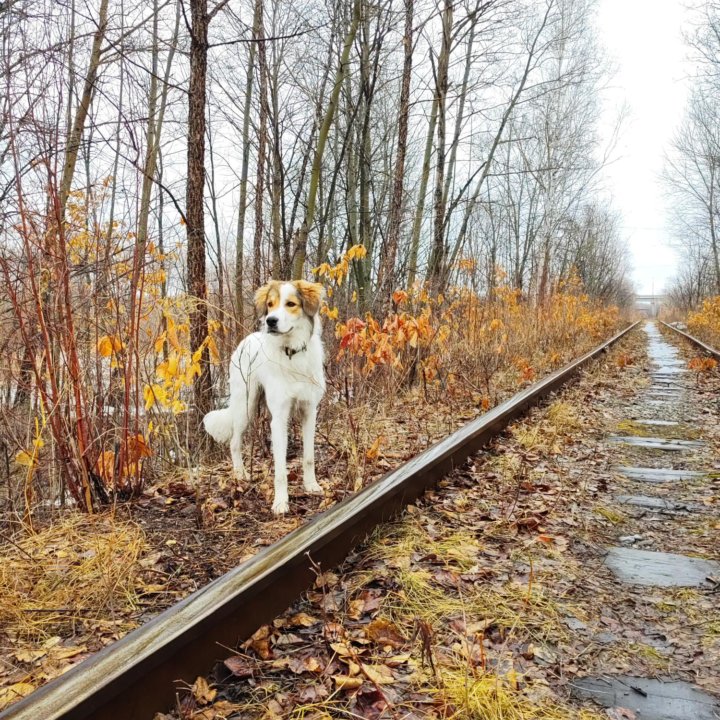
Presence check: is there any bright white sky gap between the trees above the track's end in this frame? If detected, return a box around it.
[598,0,690,293]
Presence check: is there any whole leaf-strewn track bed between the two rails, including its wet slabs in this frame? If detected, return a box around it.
[162,325,720,720]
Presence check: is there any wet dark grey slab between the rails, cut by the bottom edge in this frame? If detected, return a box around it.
[571,676,720,720]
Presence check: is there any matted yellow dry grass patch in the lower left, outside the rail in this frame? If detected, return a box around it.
[0,513,147,640]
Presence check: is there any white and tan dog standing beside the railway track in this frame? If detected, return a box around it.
[203,280,325,514]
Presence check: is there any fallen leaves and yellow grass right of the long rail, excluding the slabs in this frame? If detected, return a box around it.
[158,336,720,720]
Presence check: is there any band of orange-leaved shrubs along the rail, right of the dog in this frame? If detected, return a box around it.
[324,262,619,402]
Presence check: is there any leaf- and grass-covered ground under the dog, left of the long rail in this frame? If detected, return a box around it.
[0,334,620,713]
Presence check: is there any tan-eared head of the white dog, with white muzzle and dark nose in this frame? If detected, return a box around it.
[255,280,325,336]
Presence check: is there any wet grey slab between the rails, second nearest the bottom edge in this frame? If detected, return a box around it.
[605,547,720,587]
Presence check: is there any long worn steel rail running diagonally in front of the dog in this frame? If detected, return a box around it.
[0,323,637,720]
